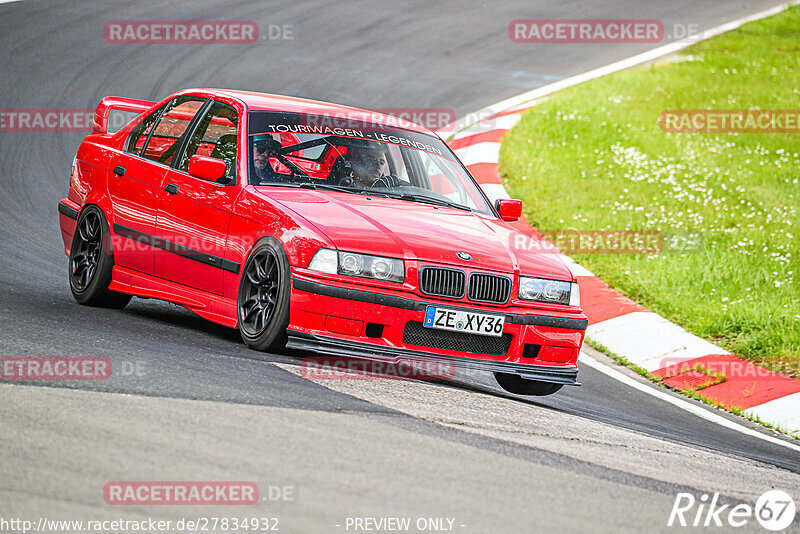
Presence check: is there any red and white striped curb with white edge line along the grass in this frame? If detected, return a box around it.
[439,4,800,437]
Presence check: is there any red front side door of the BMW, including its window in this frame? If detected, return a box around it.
[154,101,240,295]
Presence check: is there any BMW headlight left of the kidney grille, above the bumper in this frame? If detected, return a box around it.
[308,248,405,283]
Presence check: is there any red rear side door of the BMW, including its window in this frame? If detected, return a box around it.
[108,96,207,275]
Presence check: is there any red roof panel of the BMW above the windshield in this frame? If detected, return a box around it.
[186,89,433,134]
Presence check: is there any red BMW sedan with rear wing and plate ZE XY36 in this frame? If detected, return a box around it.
[58,89,587,395]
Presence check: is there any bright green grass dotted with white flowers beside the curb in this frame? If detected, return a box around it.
[500,7,800,377]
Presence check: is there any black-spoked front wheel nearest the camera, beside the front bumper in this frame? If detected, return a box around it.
[237,238,291,352]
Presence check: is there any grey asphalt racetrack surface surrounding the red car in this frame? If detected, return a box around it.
[0,0,800,533]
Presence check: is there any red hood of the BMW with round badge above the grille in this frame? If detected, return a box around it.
[256,188,572,280]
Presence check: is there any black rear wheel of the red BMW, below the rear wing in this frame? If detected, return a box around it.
[69,206,131,309]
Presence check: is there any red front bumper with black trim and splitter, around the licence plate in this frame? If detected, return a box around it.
[287,273,588,385]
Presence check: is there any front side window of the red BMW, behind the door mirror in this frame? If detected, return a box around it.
[178,102,239,181]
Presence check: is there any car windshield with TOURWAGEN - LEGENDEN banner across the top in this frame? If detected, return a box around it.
[248,111,494,215]
